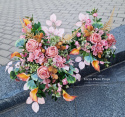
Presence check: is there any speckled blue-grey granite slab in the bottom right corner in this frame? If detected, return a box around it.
[74,83,125,117]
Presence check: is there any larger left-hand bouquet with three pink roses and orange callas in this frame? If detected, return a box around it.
[6,14,79,112]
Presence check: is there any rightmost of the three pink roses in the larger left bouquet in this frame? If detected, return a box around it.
[46,46,58,57]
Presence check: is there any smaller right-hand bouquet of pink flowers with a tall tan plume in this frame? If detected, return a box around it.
[71,9,116,71]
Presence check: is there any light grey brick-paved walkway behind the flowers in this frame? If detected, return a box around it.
[0,0,125,65]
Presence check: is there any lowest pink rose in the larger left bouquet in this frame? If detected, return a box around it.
[37,66,50,79]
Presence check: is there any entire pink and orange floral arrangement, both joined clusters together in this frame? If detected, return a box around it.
[6,9,116,112]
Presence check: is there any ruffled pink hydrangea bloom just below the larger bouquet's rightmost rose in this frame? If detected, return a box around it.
[53,55,66,68]
